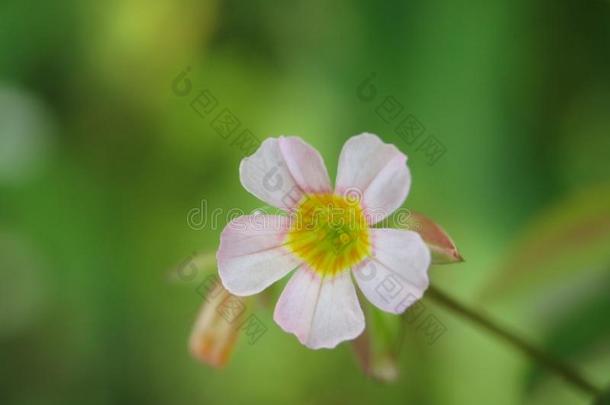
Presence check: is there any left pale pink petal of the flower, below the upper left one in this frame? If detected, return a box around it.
[216,215,300,296]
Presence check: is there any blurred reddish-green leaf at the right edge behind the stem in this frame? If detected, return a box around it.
[483,186,610,298]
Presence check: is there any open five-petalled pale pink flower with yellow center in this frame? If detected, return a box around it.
[217,134,430,349]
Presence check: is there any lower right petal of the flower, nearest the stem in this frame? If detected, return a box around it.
[354,229,430,314]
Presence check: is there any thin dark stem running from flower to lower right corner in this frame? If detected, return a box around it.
[426,285,602,397]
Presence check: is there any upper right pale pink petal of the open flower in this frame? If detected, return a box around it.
[335,133,411,224]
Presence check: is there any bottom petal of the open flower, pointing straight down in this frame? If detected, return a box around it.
[273,266,364,349]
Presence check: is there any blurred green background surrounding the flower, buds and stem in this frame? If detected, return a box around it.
[0,0,610,404]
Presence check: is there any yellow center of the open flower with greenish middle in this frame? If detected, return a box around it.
[285,194,371,275]
